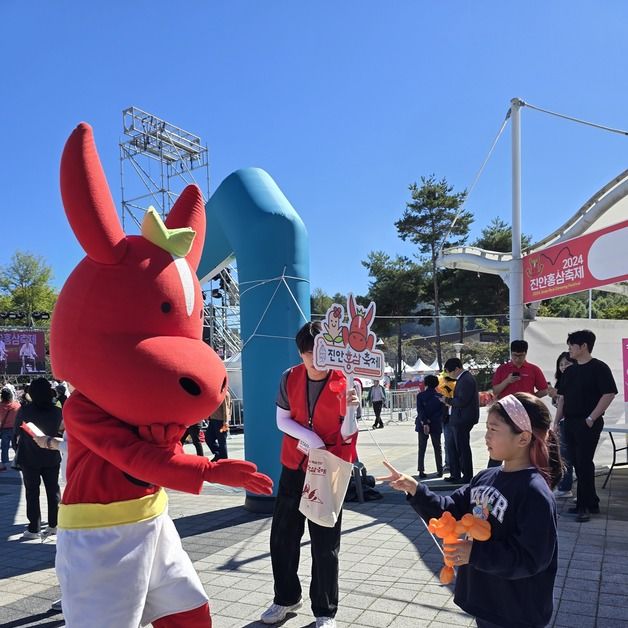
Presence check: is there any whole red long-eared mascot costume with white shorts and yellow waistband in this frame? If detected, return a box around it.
[50,124,272,628]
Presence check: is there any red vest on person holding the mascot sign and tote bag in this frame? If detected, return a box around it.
[281,364,358,471]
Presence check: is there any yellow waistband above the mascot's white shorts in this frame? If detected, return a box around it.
[58,488,168,530]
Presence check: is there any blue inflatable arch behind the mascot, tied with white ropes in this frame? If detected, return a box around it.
[198,168,310,512]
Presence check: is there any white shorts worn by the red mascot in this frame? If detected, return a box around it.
[56,512,207,628]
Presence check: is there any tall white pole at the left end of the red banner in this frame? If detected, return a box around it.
[508,98,524,342]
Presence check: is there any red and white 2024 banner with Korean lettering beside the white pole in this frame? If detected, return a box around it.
[523,220,628,303]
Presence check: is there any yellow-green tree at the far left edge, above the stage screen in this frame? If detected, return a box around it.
[0,251,57,326]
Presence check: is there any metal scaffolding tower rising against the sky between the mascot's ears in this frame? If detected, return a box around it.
[120,107,209,230]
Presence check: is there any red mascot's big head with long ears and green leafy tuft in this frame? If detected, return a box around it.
[50,123,227,425]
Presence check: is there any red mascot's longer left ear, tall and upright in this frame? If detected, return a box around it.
[61,122,127,264]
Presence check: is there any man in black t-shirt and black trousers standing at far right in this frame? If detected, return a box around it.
[554,329,617,522]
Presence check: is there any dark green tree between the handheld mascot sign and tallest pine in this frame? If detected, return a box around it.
[362,251,423,379]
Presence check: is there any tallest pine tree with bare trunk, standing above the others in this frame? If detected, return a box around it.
[395,175,473,367]
